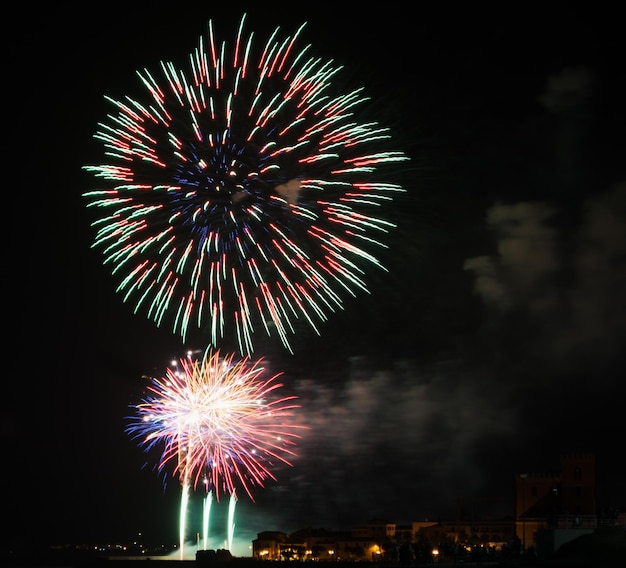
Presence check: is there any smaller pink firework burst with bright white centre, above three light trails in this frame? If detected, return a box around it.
[126,351,305,500]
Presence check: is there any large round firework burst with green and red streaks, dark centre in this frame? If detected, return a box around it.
[84,11,408,355]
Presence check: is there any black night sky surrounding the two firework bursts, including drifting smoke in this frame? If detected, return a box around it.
[6,2,626,554]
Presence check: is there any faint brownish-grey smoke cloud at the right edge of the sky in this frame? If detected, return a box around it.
[465,184,626,378]
